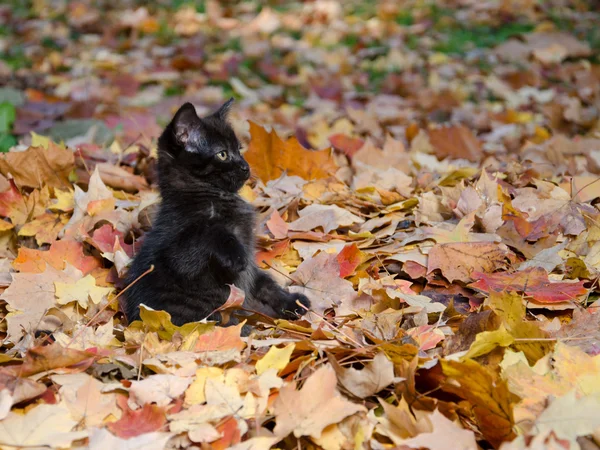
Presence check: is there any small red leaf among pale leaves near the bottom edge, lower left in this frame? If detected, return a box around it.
[108,395,167,439]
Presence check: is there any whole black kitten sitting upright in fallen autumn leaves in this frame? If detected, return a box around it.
[125,99,310,325]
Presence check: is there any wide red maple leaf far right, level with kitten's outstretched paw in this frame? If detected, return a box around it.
[469,267,588,303]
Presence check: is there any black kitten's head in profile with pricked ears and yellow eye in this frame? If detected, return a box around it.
[158,99,250,193]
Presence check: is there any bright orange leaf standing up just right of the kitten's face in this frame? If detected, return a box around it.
[244,121,337,182]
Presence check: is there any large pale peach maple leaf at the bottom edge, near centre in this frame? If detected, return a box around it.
[273,365,366,438]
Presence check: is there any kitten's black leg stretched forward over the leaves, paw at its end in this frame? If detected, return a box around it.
[250,268,310,319]
